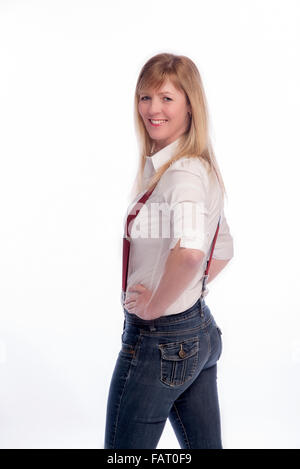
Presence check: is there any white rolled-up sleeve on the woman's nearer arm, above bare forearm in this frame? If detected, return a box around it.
[164,169,209,253]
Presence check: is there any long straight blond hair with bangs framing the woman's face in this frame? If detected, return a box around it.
[131,53,227,203]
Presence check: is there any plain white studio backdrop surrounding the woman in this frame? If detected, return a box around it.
[0,0,300,449]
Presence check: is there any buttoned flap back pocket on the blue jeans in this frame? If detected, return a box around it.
[158,337,199,387]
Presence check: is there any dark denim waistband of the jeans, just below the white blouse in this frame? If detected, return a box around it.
[123,297,206,326]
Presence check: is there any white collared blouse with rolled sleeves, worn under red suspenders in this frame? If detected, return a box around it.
[121,139,233,316]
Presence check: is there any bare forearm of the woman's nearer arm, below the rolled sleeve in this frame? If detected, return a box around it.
[147,241,201,319]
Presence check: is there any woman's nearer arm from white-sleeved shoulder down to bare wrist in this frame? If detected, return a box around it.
[147,166,209,319]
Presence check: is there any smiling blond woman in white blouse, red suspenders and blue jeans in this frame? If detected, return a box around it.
[104,53,233,449]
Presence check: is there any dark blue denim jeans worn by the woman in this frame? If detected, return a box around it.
[104,298,222,449]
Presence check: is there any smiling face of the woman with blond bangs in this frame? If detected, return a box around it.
[138,79,191,151]
